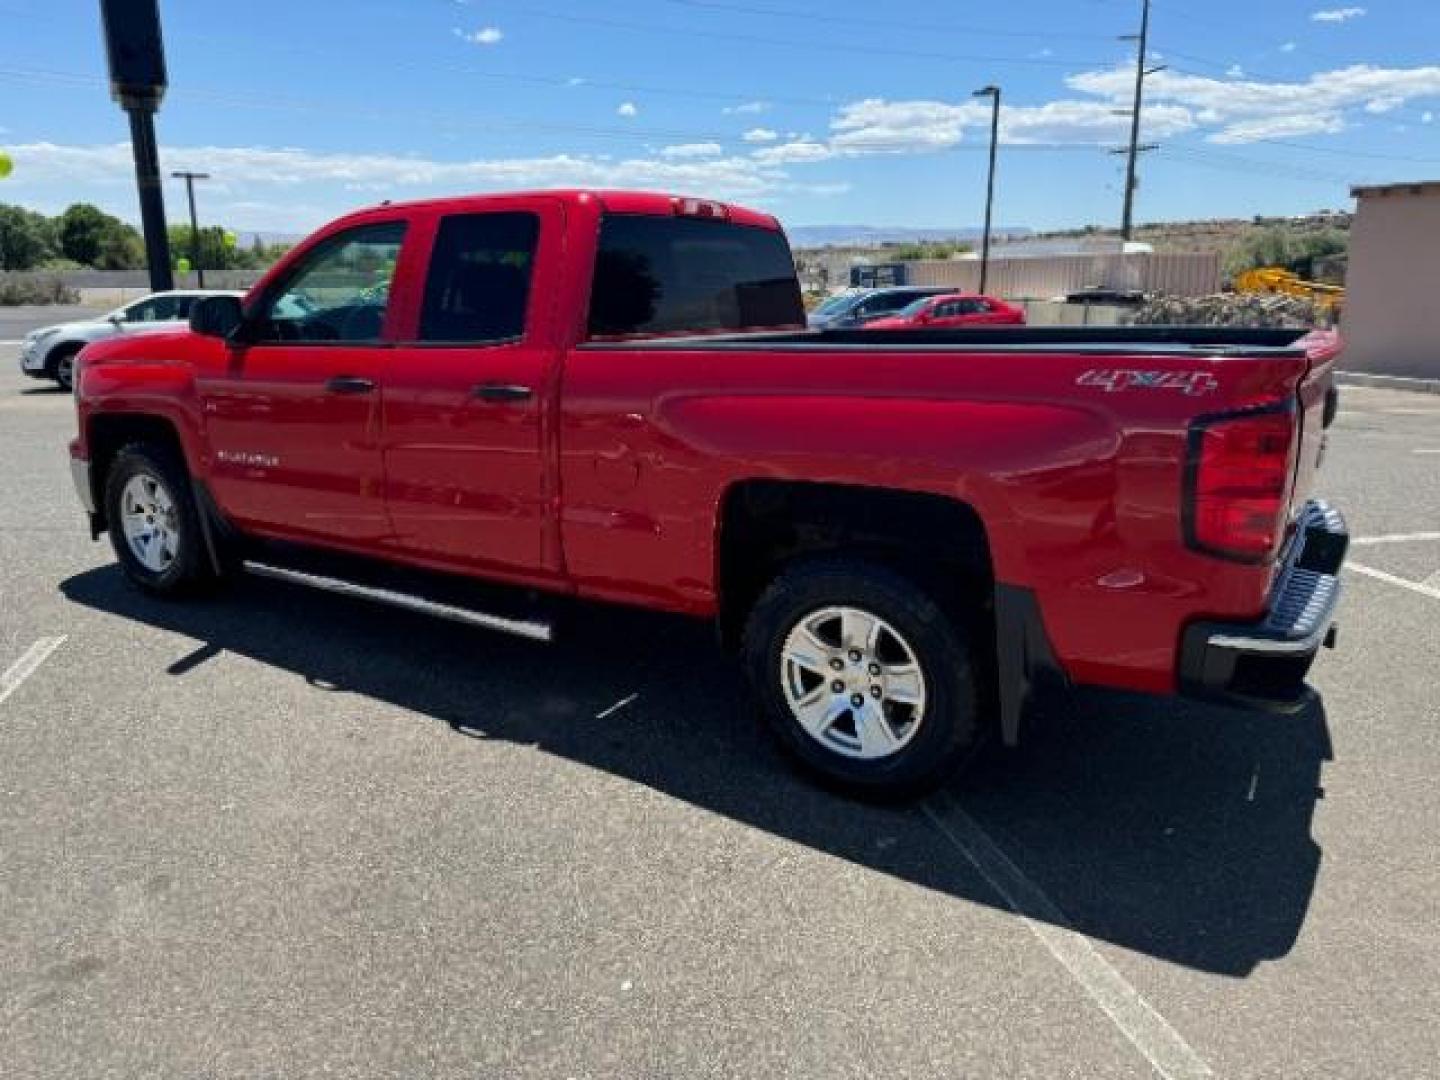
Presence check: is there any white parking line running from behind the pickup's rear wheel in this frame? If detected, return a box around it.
[922,793,1214,1080]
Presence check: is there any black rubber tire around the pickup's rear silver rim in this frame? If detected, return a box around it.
[742,557,985,801]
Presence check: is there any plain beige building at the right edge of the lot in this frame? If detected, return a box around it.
[1341,181,1440,379]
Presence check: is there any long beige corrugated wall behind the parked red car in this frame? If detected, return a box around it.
[910,252,1221,300]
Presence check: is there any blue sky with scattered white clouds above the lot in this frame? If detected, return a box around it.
[0,0,1440,232]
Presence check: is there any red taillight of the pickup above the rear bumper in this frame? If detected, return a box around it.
[1187,409,1296,560]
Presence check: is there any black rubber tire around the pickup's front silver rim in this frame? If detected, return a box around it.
[105,442,216,596]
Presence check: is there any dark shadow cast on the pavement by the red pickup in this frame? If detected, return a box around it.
[60,566,1331,976]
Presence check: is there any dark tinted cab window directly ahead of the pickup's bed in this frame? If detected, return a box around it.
[589,213,805,340]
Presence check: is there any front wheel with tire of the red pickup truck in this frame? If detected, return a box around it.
[105,442,215,595]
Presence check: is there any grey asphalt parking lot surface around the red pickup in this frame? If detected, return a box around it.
[0,334,1440,1079]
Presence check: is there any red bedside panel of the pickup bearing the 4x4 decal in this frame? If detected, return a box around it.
[560,344,1305,690]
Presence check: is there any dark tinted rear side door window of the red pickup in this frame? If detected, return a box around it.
[420,212,540,344]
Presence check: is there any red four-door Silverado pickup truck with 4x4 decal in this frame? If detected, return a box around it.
[71,192,1346,796]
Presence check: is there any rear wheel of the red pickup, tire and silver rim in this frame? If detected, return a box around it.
[744,557,982,799]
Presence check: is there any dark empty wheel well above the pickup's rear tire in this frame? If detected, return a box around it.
[717,480,994,645]
